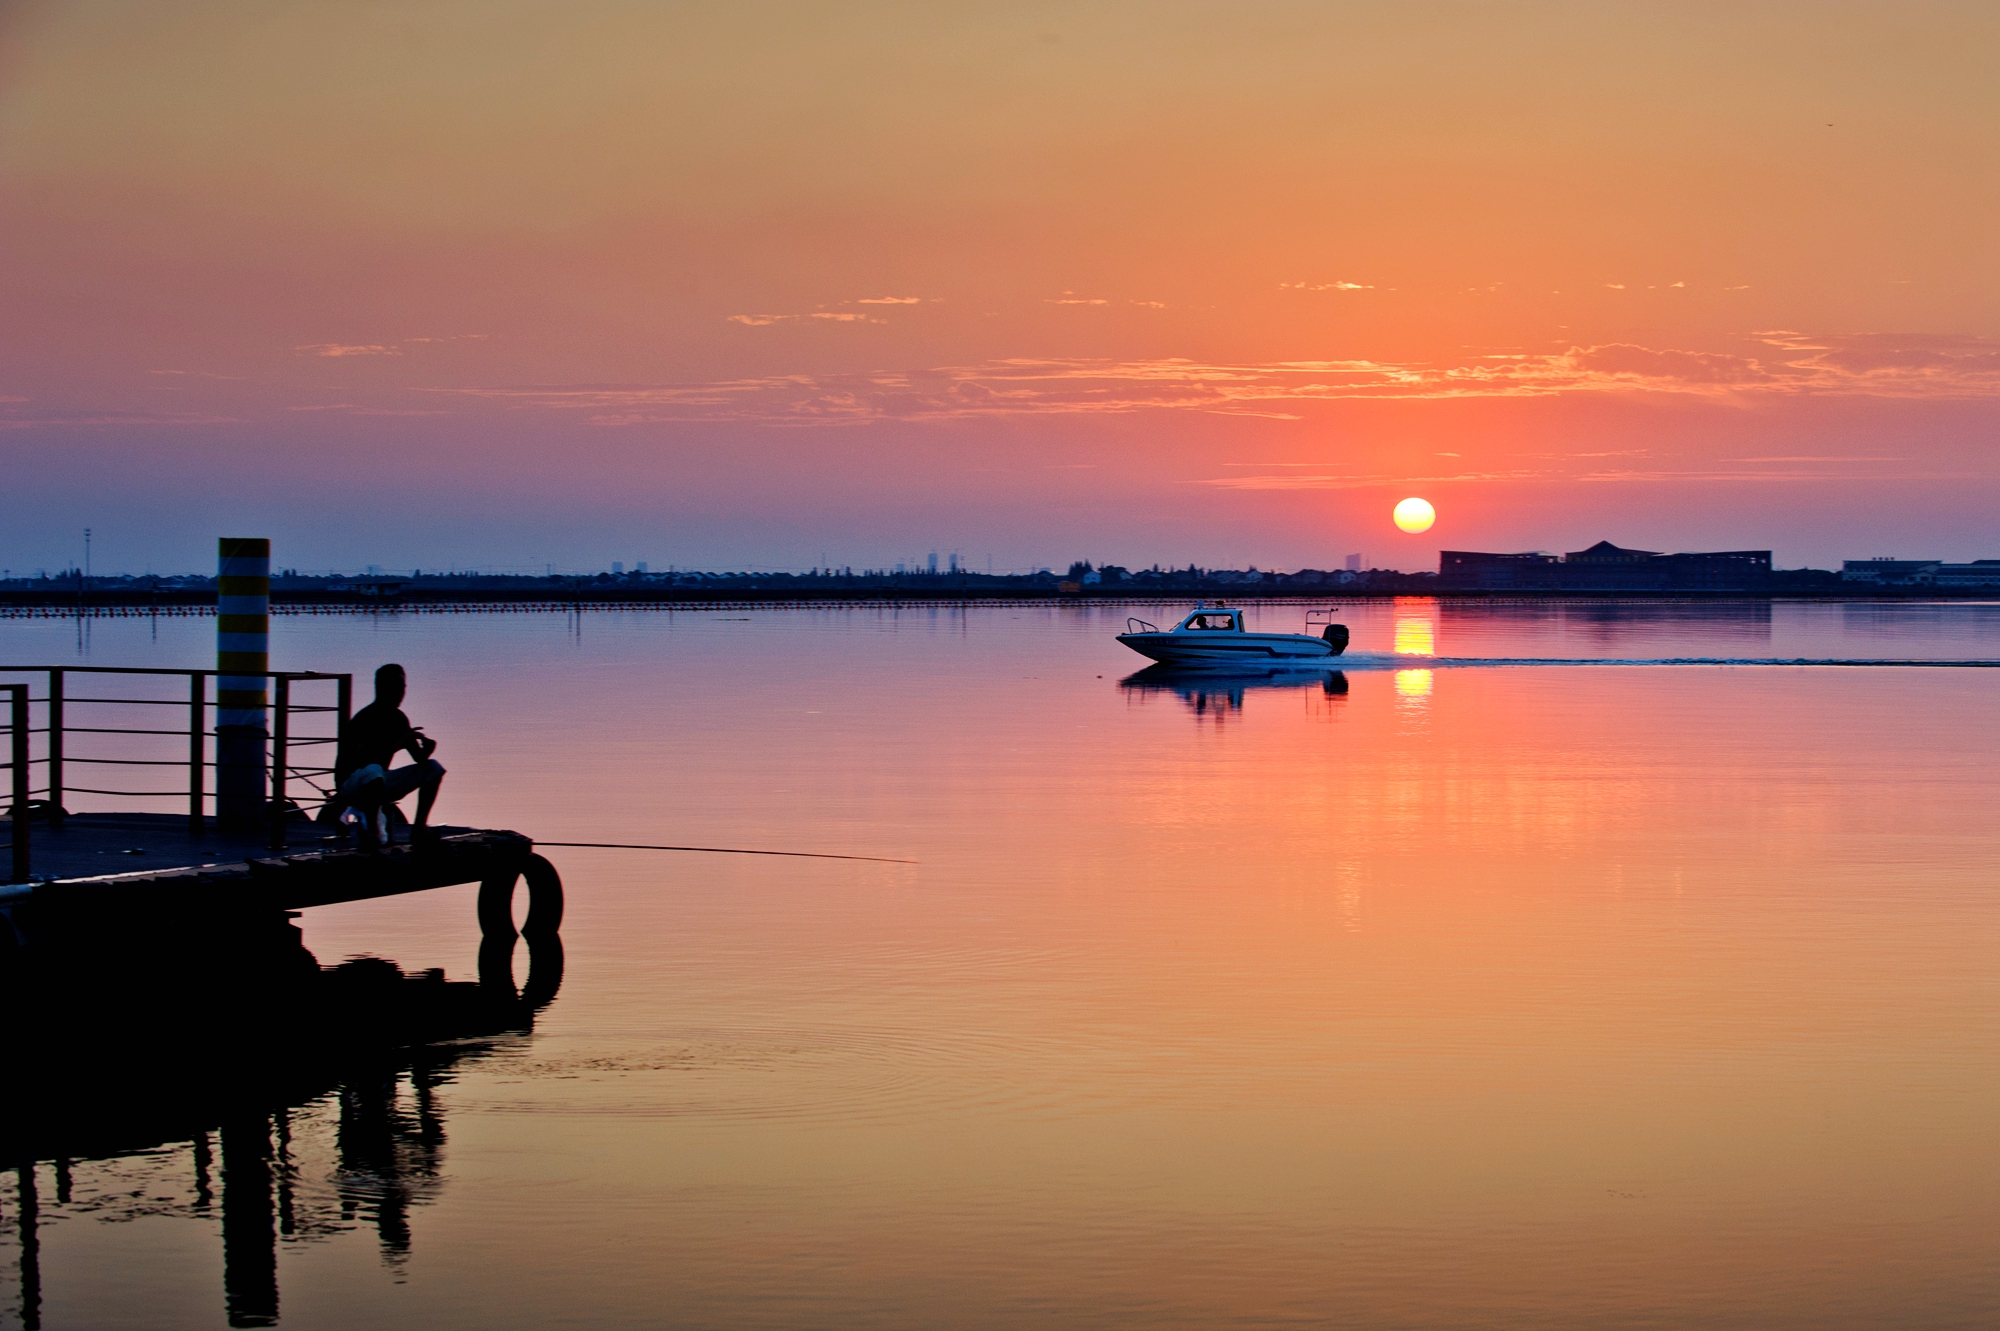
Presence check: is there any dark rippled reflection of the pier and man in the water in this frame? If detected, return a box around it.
[0,935,562,1329]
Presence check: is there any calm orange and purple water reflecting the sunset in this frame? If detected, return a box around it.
[0,602,2000,1329]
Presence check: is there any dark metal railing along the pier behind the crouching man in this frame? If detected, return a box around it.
[0,666,354,881]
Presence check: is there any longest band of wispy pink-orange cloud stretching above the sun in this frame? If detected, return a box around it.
[426,333,2000,424]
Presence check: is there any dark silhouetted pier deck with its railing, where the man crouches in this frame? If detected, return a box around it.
[0,666,562,951]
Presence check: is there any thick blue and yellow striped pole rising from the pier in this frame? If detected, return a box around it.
[216,536,270,831]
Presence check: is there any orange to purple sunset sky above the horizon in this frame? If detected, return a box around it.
[0,0,2000,576]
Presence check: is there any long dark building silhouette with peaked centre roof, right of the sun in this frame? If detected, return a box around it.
[1438,542,1770,592]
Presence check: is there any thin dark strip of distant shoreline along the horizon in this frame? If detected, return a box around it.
[0,586,2000,618]
